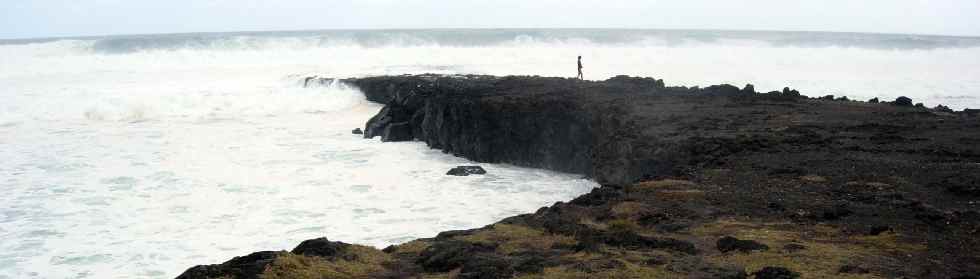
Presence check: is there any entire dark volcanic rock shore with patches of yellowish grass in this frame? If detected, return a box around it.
[178,75,980,278]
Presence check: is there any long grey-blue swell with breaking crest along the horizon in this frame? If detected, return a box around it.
[0,29,980,54]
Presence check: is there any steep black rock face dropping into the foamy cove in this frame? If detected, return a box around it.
[346,75,780,185]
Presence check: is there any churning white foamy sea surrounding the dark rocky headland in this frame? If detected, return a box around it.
[0,30,980,278]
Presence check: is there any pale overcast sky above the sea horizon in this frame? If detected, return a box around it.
[0,0,980,38]
